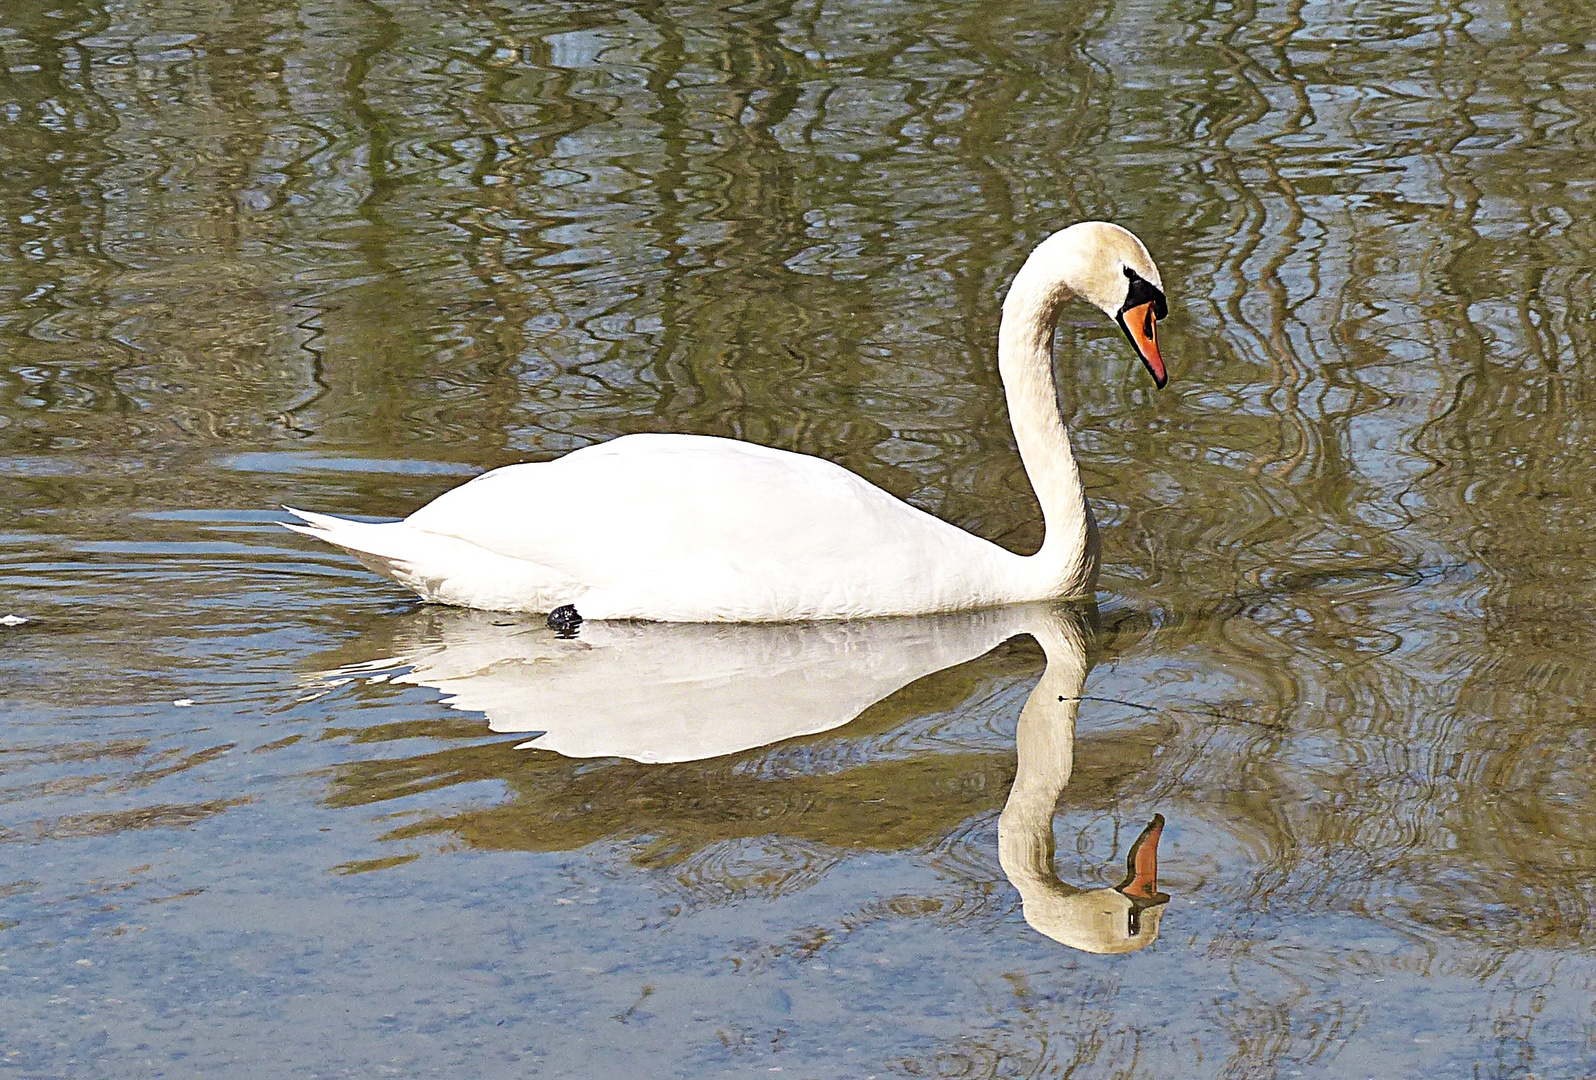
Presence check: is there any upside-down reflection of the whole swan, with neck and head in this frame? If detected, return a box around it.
[323,606,1170,952]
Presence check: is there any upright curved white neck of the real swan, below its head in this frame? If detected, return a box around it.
[998,269,1098,600]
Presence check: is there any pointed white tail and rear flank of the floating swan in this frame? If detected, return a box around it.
[281,506,586,613]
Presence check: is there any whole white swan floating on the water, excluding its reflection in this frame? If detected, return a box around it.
[287,222,1167,625]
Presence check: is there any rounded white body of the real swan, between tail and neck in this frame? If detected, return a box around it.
[405,434,1018,621]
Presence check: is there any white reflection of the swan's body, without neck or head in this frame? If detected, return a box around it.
[338,608,1026,763]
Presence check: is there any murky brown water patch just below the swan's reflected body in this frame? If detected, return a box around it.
[330,718,1159,861]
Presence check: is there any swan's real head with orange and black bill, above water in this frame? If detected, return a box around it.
[1004,222,1170,389]
